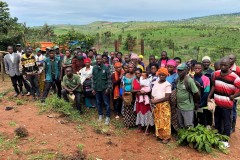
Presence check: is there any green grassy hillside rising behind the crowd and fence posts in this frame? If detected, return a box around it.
[51,13,240,62]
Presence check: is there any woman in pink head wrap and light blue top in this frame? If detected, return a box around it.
[166,59,179,131]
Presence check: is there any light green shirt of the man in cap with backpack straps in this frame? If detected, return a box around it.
[177,78,198,111]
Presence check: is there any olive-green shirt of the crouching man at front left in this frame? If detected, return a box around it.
[62,74,81,92]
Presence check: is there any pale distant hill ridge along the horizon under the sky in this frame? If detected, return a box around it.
[52,12,240,35]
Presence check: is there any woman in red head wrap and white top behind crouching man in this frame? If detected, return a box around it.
[79,58,96,108]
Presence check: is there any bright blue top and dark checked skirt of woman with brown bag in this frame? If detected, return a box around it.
[122,76,136,127]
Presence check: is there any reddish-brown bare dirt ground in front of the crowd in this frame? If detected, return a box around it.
[0,79,240,160]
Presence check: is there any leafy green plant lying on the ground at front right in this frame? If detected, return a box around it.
[177,125,229,154]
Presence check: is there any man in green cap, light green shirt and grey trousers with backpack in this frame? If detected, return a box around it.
[176,63,200,128]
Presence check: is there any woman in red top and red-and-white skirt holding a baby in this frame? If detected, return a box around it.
[133,68,154,135]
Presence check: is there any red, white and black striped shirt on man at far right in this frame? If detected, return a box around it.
[213,70,240,109]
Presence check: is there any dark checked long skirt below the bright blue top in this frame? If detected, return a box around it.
[122,100,136,127]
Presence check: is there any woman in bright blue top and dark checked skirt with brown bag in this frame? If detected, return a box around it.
[122,63,136,128]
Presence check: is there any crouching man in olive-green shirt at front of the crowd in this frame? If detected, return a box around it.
[62,67,82,114]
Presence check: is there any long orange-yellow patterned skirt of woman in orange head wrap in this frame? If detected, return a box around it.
[154,102,171,139]
